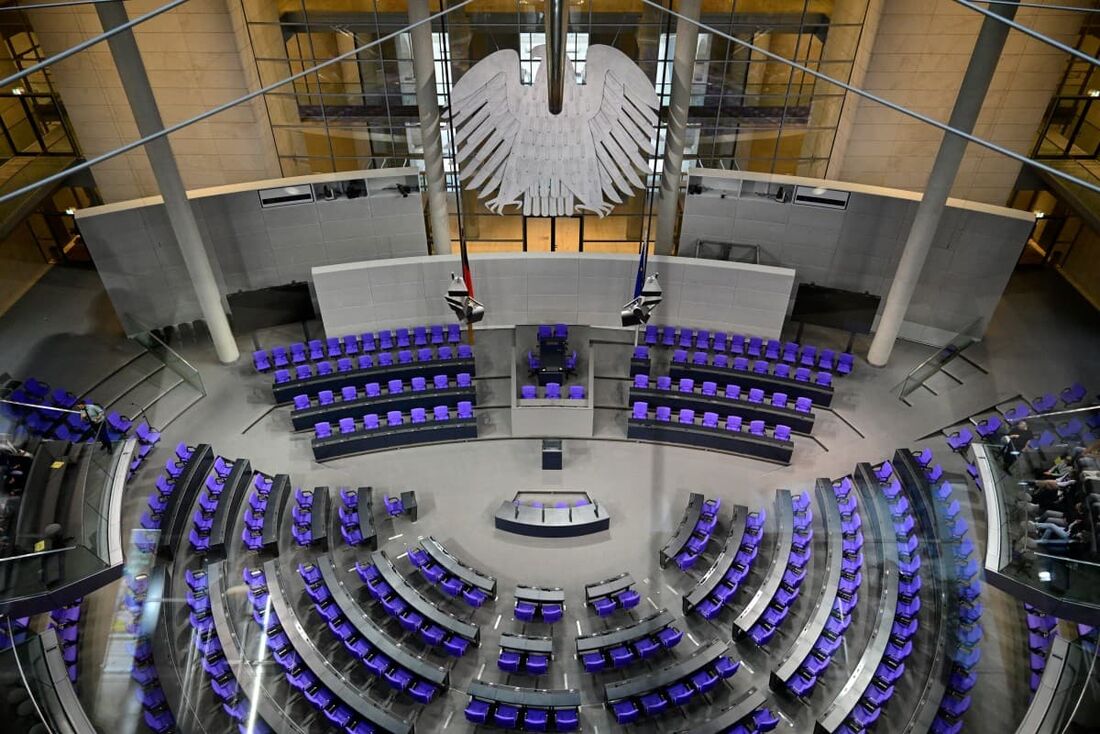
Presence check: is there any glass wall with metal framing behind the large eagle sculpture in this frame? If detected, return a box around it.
[241,0,867,252]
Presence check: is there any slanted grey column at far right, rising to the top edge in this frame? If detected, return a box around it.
[867,4,1016,366]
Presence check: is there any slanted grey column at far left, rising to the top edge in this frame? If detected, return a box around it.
[96,2,241,363]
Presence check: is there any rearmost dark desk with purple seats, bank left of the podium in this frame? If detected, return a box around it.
[272,344,474,404]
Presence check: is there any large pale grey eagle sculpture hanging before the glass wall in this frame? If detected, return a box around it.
[451,46,657,217]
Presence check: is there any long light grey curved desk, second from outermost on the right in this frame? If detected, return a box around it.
[816,463,899,732]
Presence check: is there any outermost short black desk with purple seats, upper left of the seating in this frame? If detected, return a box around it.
[138,443,213,560]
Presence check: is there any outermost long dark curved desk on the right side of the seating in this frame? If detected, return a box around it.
[893,449,959,734]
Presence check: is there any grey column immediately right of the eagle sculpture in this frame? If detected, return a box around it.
[656,0,700,255]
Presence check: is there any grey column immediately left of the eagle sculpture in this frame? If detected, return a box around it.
[408,0,451,255]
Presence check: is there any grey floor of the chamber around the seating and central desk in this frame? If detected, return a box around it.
[0,260,1100,732]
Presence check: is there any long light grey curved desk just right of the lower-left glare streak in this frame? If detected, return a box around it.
[264,559,413,734]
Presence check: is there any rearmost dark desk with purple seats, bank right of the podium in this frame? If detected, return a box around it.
[660,354,833,407]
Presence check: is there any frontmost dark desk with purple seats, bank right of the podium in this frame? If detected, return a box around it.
[626,402,794,463]
